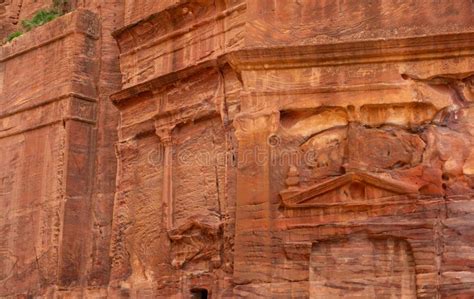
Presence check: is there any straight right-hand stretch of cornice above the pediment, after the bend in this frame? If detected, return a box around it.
[226,32,474,71]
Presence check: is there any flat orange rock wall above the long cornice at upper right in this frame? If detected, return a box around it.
[246,0,473,47]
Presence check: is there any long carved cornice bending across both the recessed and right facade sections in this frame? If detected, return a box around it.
[111,32,474,106]
